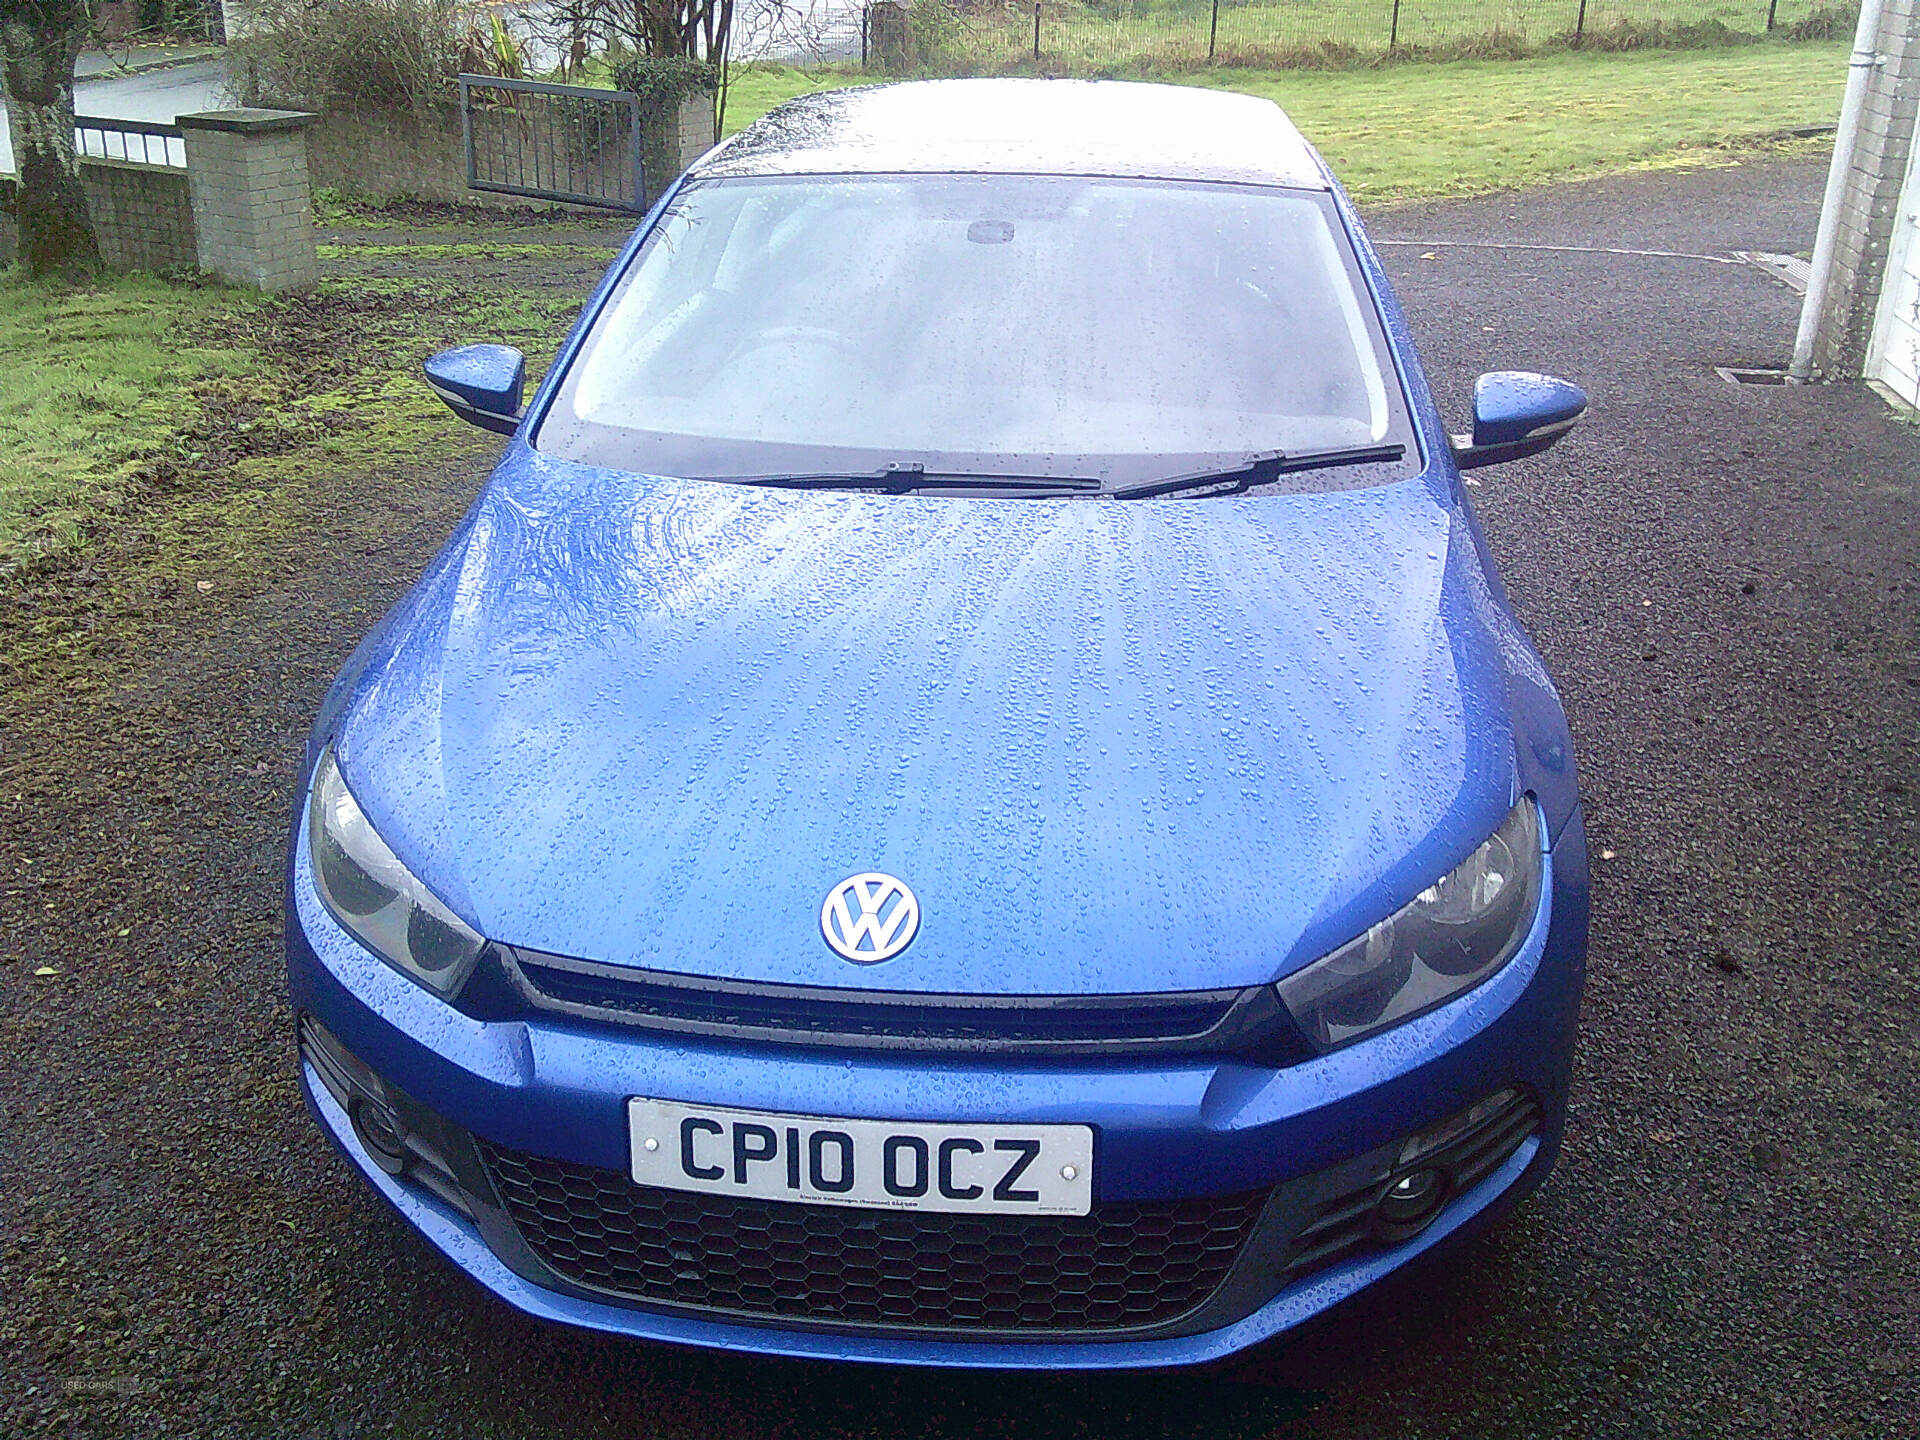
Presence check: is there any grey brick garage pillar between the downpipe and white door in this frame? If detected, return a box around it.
[1812,0,1920,380]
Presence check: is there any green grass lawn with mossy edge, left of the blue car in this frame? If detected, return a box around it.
[0,264,579,587]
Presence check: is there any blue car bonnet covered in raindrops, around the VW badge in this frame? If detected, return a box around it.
[338,445,1524,995]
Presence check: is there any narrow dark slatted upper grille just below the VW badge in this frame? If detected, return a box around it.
[499,947,1311,1066]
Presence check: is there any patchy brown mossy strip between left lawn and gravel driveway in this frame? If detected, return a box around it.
[0,268,582,695]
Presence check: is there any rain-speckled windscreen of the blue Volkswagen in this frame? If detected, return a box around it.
[538,175,1411,486]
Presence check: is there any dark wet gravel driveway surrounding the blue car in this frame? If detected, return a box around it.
[0,152,1920,1440]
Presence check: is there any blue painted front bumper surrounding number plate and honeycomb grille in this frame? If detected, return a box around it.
[288,812,1586,1369]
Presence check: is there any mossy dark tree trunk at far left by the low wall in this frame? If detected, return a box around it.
[0,0,100,276]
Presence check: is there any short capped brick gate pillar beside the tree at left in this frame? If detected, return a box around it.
[175,109,319,292]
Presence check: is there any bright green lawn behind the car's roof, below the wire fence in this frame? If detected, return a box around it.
[726,42,1847,202]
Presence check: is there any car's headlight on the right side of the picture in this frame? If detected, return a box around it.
[1279,797,1540,1050]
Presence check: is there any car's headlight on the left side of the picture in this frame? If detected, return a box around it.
[307,747,486,996]
